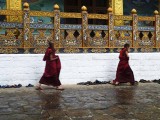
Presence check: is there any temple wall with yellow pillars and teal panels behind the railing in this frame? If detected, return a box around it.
[0,0,160,25]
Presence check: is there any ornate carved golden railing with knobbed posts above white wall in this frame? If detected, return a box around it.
[0,1,160,53]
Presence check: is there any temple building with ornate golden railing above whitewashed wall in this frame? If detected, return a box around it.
[0,0,160,85]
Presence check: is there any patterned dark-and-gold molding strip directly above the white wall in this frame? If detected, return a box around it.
[0,47,160,54]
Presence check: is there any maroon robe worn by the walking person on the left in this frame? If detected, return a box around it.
[39,48,61,86]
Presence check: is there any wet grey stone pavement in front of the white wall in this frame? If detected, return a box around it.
[0,83,160,120]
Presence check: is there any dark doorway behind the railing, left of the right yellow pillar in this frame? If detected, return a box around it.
[64,0,109,25]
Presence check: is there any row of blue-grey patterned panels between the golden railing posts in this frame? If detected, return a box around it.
[0,22,155,31]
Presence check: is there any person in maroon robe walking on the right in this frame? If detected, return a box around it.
[113,44,135,85]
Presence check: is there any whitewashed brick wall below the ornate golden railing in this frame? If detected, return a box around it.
[0,53,160,85]
